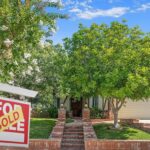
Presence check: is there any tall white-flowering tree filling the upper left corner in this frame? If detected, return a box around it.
[0,0,67,84]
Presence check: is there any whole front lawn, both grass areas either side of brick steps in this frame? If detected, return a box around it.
[30,118,150,140]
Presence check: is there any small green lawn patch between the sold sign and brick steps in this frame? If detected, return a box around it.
[30,118,56,139]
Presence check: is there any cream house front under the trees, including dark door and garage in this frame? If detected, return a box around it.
[57,96,150,119]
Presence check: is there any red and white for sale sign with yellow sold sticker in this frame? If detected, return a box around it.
[0,98,31,147]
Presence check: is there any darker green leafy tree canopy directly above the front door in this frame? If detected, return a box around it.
[64,25,100,98]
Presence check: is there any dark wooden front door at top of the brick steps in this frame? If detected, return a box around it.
[71,98,82,117]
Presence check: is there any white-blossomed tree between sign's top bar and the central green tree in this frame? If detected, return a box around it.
[15,42,67,109]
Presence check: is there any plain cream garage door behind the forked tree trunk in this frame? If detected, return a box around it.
[119,100,150,119]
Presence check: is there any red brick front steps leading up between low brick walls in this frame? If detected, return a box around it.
[61,123,84,150]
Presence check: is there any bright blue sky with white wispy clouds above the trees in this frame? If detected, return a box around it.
[50,0,150,44]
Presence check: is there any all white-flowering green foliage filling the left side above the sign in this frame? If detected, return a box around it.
[0,0,67,108]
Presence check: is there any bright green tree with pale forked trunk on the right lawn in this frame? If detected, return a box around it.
[98,22,149,128]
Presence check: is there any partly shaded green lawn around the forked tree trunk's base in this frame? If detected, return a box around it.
[94,124,150,140]
